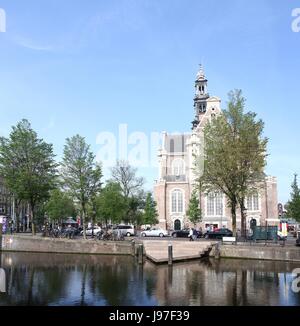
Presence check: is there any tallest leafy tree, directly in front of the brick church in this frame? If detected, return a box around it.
[196,90,268,235]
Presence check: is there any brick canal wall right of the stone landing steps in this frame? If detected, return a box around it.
[210,244,300,262]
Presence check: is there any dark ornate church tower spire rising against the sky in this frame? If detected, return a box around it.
[192,65,209,129]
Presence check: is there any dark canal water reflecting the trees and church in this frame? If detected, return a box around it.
[0,253,300,306]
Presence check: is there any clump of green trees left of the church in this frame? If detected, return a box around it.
[0,120,158,235]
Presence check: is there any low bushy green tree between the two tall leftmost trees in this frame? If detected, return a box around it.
[44,189,76,222]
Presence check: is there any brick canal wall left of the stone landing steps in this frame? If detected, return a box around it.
[0,235,132,255]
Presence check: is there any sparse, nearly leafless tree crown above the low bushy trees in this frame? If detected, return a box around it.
[111,161,145,198]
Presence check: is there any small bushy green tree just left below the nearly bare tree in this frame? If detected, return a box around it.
[95,182,127,226]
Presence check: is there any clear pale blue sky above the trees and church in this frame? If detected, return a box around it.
[0,0,300,202]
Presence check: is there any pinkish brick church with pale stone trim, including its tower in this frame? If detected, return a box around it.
[154,67,280,230]
